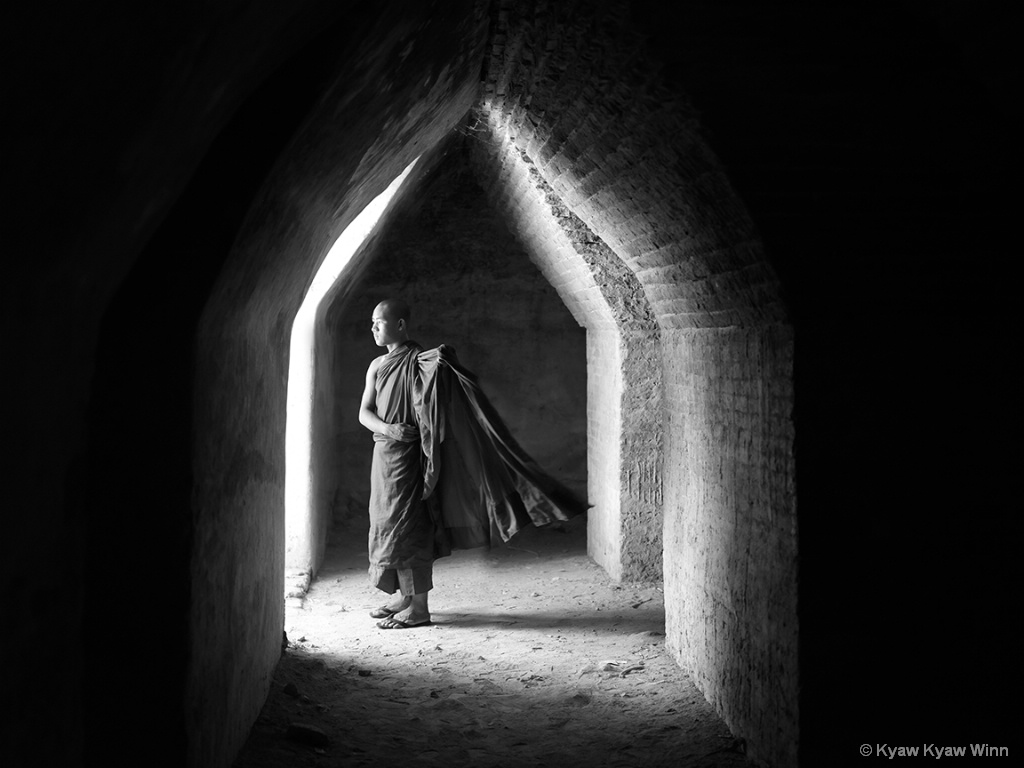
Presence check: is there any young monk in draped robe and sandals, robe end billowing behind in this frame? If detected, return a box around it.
[359,299,587,630]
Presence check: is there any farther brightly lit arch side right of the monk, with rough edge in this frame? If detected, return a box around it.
[475,110,662,581]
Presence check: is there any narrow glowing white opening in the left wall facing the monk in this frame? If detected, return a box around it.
[285,158,419,594]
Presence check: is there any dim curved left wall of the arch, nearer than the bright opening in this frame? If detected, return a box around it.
[186,2,485,766]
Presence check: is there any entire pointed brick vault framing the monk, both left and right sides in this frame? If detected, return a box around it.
[193,7,797,764]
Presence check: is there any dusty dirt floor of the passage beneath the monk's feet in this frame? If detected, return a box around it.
[236,520,752,768]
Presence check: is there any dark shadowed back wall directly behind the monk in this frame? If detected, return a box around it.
[317,141,587,540]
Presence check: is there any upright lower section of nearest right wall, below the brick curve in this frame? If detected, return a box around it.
[664,326,799,765]
